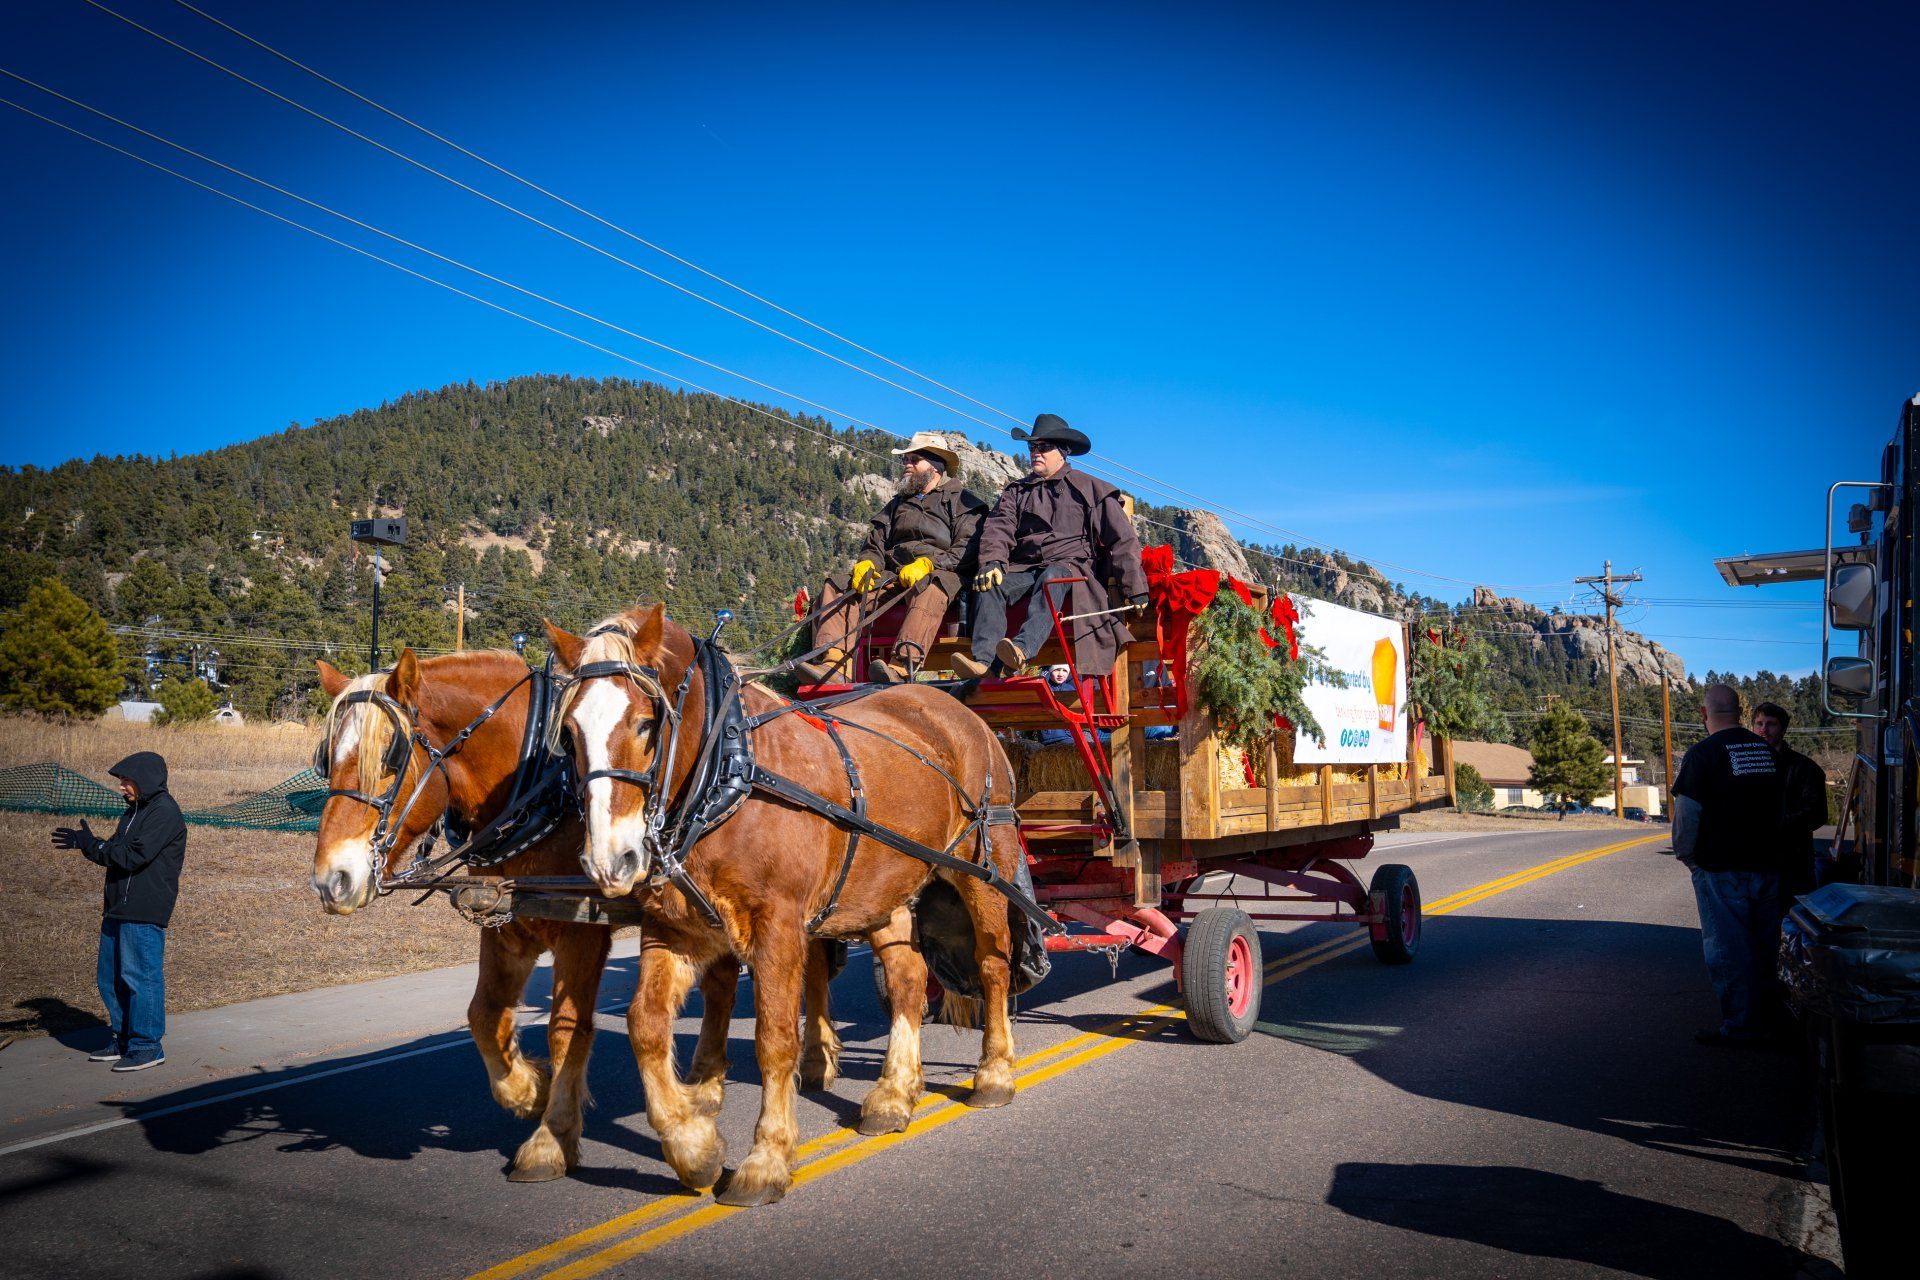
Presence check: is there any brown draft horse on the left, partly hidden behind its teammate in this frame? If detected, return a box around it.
[313,649,839,1182]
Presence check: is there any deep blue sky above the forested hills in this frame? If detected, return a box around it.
[0,0,1920,672]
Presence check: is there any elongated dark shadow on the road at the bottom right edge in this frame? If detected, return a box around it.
[1327,1163,1803,1280]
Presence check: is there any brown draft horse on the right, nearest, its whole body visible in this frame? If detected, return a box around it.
[547,604,1023,1205]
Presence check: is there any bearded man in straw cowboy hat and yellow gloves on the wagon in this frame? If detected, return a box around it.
[801,432,987,683]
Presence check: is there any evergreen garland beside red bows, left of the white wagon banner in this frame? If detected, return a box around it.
[1187,585,1346,752]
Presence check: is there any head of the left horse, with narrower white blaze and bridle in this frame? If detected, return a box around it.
[313,649,447,915]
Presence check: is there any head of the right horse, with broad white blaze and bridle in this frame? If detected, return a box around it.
[547,604,699,896]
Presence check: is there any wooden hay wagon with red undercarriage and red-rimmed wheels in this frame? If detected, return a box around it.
[821,579,1453,1042]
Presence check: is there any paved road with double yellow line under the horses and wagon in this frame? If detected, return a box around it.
[0,827,1830,1280]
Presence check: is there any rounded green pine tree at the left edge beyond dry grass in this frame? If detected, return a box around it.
[0,578,123,716]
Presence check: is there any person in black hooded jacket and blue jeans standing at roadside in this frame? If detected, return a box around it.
[54,750,186,1071]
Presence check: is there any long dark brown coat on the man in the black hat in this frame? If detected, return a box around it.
[979,466,1146,676]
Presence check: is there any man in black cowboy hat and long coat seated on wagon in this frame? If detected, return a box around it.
[954,413,1146,676]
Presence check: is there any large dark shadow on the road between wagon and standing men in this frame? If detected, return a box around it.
[1258,917,1811,1178]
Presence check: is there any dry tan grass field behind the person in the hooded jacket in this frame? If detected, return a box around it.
[0,718,478,1034]
